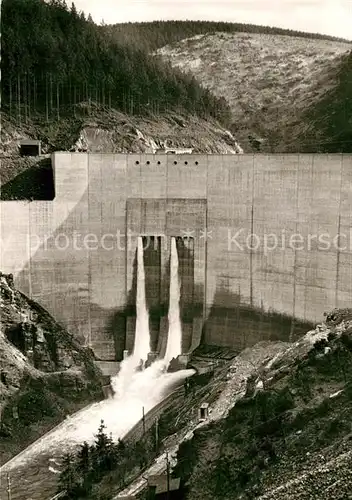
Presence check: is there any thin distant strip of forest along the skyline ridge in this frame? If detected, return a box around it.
[102,21,350,51]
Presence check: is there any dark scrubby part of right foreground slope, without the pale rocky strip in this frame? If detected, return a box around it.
[174,309,352,500]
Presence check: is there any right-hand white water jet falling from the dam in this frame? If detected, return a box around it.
[164,238,182,364]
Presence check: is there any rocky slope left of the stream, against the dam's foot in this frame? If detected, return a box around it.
[0,273,103,463]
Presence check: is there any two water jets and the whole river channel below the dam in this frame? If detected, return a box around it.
[0,238,194,500]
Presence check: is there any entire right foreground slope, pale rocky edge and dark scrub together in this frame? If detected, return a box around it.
[92,309,352,500]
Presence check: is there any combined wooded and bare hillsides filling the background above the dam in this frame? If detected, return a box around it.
[1,0,352,153]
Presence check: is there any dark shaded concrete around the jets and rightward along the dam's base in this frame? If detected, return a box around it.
[109,238,313,360]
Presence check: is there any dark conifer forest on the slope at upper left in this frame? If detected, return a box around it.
[1,0,230,123]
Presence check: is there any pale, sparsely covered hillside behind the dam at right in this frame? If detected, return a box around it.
[155,33,352,153]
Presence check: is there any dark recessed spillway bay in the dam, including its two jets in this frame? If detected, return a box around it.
[125,235,196,364]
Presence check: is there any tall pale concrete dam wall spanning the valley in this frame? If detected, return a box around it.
[0,153,352,361]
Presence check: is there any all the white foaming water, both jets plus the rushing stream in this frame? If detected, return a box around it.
[0,238,194,472]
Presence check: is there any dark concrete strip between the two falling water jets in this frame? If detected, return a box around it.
[142,236,161,351]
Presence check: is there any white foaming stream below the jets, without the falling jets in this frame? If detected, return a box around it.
[0,360,194,471]
